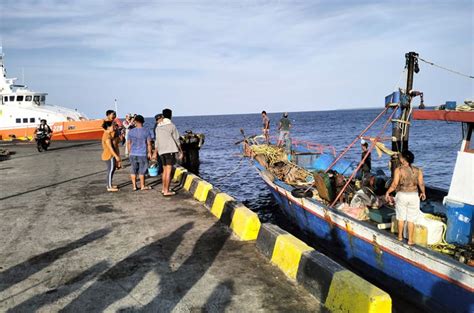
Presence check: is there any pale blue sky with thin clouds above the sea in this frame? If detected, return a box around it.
[0,0,474,118]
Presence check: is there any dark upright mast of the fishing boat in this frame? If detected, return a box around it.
[392,52,420,152]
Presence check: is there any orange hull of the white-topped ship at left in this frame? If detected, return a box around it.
[0,120,104,141]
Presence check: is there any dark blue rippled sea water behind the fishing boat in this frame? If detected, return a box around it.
[143,108,462,220]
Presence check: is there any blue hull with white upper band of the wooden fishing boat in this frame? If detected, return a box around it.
[255,161,474,312]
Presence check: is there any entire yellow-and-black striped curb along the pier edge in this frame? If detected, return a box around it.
[173,167,392,313]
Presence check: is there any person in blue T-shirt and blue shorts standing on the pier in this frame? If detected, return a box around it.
[127,115,151,190]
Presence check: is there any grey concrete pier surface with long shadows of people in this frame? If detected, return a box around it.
[0,142,323,312]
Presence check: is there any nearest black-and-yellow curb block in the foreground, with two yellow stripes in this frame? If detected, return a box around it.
[257,224,392,313]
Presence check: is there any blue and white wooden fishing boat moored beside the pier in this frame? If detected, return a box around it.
[242,52,474,312]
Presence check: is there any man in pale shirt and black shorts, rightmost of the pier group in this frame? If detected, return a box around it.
[154,109,183,197]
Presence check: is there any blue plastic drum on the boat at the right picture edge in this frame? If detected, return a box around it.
[444,198,474,245]
